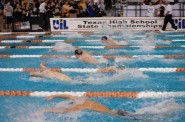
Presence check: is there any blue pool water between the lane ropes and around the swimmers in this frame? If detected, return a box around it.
[0,32,185,122]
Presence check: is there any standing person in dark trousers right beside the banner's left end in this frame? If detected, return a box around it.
[45,3,53,30]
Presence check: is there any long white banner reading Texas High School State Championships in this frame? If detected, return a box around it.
[50,17,185,31]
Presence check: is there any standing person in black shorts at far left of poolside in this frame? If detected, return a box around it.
[4,1,13,29]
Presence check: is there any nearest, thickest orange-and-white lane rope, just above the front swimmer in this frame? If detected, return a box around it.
[0,91,185,99]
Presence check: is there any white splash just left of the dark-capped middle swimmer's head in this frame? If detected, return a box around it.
[53,42,75,52]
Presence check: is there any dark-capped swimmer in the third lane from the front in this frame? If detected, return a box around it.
[75,49,98,64]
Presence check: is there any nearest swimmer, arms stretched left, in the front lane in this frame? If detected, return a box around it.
[42,94,130,116]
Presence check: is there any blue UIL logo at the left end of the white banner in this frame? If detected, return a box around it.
[53,19,68,30]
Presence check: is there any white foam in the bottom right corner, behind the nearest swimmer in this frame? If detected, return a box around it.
[133,99,185,122]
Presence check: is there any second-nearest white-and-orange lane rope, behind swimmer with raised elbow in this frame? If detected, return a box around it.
[0,67,185,73]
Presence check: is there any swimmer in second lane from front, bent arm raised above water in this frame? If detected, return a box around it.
[30,62,72,81]
